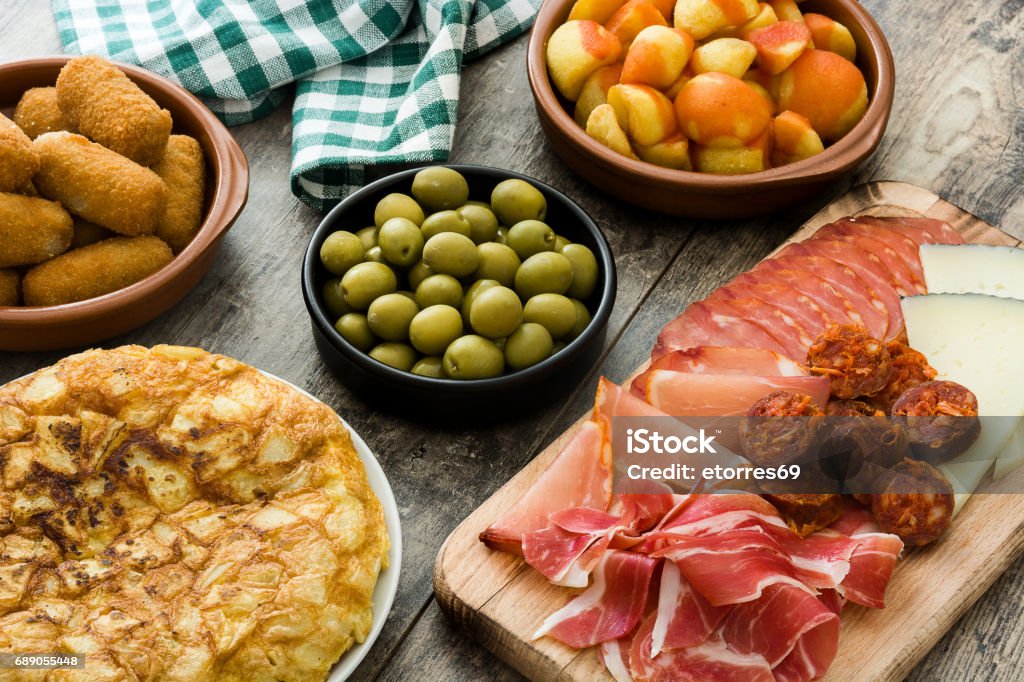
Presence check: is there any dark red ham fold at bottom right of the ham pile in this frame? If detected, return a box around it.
[722,585,839,670]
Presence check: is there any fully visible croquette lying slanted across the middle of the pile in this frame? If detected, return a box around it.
[35,132,167,236]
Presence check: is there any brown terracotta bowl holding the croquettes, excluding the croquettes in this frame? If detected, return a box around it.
[0,56,249,350]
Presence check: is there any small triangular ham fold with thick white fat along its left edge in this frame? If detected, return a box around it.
[651,561,730,656]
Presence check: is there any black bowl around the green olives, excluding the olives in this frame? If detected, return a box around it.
[303,165,615,392]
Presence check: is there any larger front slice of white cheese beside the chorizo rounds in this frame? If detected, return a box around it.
[903,294,1024,510]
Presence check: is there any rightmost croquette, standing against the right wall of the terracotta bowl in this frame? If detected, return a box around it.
[153,135,206,254]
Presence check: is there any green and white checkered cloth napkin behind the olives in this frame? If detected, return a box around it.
[52,0,541,210]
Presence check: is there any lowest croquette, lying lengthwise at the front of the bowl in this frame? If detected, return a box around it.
[23,237,173,305]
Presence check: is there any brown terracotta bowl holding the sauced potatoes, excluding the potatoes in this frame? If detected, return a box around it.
[526,0,895,218]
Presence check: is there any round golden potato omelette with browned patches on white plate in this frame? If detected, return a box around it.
[0,346,389,682]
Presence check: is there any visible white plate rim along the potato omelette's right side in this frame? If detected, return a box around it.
[260,370,401,682]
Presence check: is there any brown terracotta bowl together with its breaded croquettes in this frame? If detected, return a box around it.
[0,56,249,351]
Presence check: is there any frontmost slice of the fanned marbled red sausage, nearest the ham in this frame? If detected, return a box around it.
[651,301,803,360]
